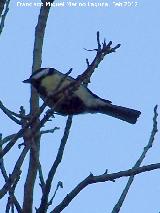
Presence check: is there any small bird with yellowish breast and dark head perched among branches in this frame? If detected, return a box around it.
[23,68,141,124]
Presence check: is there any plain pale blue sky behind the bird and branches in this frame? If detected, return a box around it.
[0,0,160,213]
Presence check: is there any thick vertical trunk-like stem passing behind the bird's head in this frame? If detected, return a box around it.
[23,0,56,213]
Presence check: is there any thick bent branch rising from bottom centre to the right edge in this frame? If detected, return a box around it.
[50,163,160,213]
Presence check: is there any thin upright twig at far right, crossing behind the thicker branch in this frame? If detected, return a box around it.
[112,105,158,213]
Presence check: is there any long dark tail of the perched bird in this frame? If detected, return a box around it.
[88,103,141,124]
